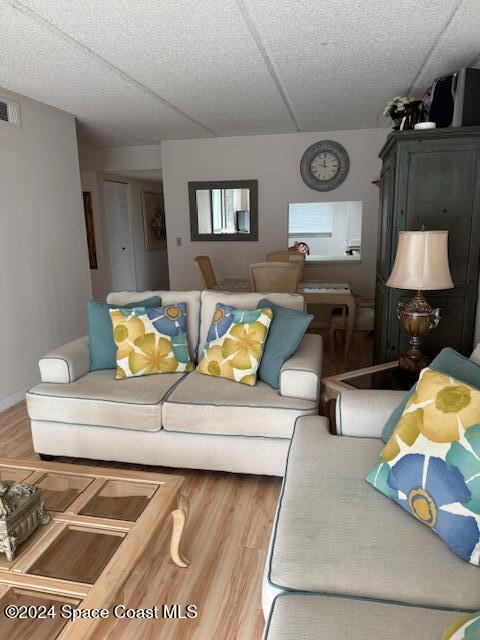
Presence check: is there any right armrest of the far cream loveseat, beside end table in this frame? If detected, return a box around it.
[279,333,322,402]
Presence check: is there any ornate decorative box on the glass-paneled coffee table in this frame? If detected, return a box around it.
[0,482,50,561]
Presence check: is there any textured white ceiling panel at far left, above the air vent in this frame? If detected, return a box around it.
[0,3,212,143]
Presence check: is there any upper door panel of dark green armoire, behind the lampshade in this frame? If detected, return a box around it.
[406,149,477,284]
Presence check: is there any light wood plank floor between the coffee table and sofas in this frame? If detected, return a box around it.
[0,332,372,640]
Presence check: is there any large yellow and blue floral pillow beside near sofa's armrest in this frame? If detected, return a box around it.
[367,369,480,566]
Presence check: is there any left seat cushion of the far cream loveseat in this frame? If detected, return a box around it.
[27,369,185,430]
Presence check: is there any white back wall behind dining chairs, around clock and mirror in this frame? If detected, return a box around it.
[162,129,388,293]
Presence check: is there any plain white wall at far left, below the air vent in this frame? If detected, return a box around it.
[0,89,91,409]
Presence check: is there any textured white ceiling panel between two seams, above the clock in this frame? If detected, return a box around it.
[244,0,464,130]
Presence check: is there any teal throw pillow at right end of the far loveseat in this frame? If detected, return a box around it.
[257,298,313,389]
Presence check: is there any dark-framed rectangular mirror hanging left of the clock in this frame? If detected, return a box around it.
[188,180,258,241]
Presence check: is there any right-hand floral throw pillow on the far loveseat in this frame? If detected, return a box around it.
[197,303,273,386]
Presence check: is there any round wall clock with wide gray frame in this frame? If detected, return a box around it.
[300,140,350,191]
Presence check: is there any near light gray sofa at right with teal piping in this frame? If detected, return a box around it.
[262,347,480,640]
